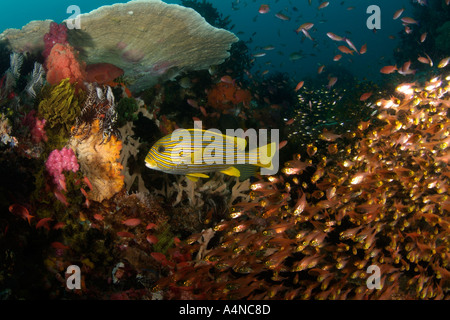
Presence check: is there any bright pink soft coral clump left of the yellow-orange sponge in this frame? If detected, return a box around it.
[45,148,80,190]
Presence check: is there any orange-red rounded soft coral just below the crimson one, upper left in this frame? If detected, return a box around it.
[46,43,86,86]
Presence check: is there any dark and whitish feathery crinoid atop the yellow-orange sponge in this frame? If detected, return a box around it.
[72,83,120,143]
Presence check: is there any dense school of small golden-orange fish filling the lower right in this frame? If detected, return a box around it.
[153,74,450,299]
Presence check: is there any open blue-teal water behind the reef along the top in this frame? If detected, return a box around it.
[0,0,411,80]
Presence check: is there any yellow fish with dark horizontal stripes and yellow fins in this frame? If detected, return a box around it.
[145,129,278,181]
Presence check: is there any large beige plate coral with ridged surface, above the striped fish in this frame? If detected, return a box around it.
[65,0,237,91]
